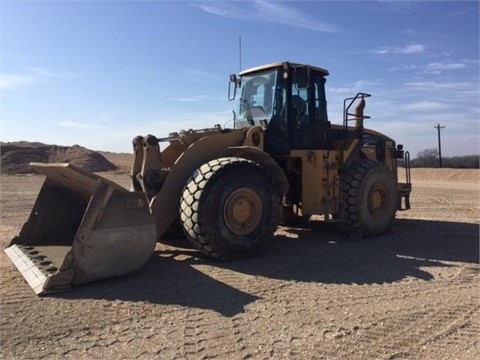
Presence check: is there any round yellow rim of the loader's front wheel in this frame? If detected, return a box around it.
[223,188,263,235]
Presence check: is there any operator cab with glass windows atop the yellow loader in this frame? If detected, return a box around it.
[229,62,330,155]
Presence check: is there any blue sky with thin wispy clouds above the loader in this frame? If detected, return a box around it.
[0,0,480,157]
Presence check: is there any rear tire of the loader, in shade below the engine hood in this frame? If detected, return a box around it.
[337,160,397,237]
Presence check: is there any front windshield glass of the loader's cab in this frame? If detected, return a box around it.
[235,69,277,129]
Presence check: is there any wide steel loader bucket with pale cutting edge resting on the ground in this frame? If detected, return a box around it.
[5,163,156,294]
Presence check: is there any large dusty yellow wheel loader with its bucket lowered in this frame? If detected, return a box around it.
[5,62,411,294]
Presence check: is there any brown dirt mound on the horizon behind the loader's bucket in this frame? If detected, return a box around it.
[0,141,117,174]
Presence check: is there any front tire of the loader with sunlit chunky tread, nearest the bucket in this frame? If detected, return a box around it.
[180,157,281,260]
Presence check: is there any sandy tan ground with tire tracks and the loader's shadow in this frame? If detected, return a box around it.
[0,169,480,359]
